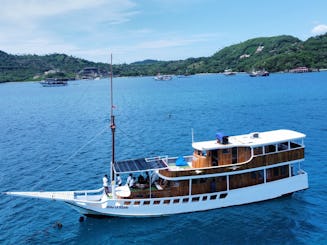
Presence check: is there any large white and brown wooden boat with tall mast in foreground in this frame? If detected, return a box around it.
[5,58,309,217]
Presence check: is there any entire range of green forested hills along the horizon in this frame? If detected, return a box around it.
[0,34,327,82]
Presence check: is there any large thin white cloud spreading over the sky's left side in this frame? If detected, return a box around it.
[0,0,138,58]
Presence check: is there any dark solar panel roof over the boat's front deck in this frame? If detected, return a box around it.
[114,158,167,173]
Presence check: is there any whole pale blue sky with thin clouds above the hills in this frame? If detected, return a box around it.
[0,0,327,64]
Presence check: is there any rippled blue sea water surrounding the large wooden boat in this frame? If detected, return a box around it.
[0,72,327,244]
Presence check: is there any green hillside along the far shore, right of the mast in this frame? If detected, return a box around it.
[116,34,327,76]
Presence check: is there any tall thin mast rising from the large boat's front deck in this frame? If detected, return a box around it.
[110,54,116,184]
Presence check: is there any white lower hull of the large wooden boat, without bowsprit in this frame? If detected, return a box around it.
[62,172,308,217]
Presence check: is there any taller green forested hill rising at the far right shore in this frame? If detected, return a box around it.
[208,34,327,72]
